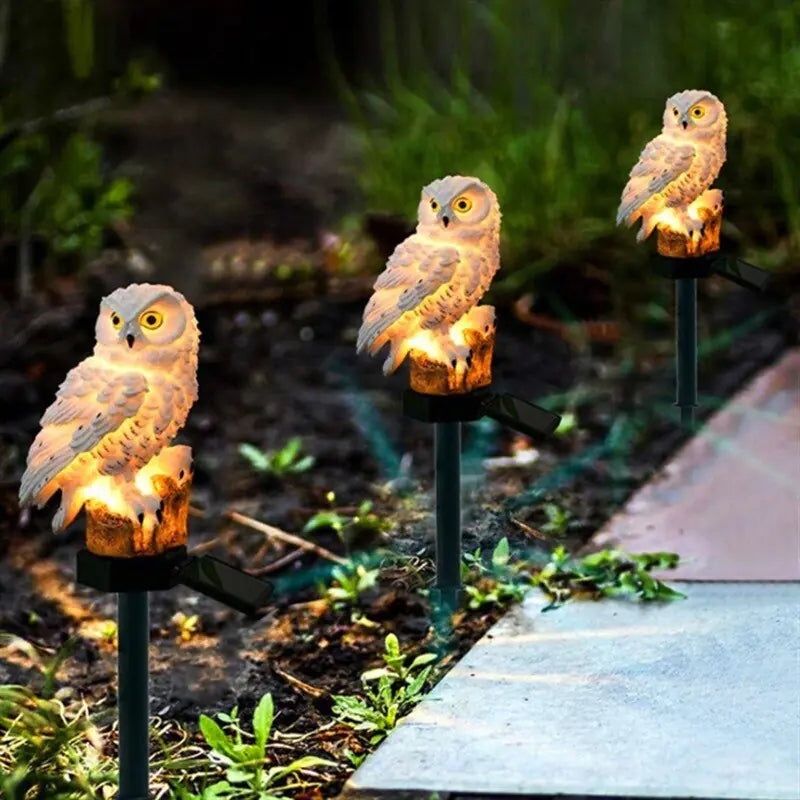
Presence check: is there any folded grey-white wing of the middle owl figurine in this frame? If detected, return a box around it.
[356,236,460,352]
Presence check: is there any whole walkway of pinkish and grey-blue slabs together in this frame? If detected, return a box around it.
[346,350,800,800]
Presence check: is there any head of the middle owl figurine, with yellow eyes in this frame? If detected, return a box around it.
[417,175,500,233]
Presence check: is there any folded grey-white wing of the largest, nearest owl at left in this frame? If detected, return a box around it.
[19,359,147,506]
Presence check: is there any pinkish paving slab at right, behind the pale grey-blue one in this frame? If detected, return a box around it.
[588,349,800,581]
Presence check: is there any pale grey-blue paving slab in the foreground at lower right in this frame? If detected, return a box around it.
[345,583,800,800]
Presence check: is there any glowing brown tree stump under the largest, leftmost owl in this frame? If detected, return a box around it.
[86,475,192,558]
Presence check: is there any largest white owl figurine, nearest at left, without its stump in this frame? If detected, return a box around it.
[19,283,200,531]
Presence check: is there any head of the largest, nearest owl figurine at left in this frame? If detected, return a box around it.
[95,283,200,361]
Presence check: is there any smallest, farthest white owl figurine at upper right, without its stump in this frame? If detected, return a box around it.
[617,89,728,241]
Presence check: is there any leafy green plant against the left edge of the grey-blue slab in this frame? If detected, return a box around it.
[333,633,436,745]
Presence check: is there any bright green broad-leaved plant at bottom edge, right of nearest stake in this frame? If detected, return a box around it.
[195,693,334,800]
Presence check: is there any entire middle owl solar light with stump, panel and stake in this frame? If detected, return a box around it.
[356,175,560,620]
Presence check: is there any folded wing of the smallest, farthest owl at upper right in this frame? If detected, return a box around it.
[617,136,696,225]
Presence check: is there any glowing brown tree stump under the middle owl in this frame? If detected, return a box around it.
[409,325,495,395]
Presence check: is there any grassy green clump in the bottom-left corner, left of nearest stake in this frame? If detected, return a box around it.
[0,635,116,800]
